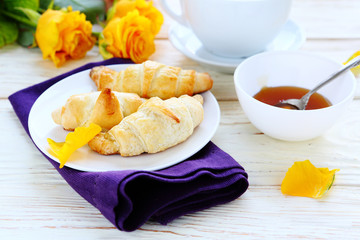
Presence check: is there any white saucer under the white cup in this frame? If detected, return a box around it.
[169,20,306,74]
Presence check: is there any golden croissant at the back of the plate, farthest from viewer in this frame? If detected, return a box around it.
[90,60,213,99]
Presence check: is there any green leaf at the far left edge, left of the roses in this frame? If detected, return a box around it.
[0,15,19,47]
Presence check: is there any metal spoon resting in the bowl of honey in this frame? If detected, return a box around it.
[275,57,360,110]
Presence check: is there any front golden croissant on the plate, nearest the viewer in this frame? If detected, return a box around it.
[89,95,204,156]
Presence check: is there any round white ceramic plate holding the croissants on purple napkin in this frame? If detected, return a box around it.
[28,64,220,172]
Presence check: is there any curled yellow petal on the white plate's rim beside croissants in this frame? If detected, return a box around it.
[47,123,101,168]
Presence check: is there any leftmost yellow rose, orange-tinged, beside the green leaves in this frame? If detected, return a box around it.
[35,7,96,67]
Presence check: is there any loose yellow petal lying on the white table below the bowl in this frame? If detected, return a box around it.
[281,160,339,198]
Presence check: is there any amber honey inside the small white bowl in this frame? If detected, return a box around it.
[254,86,331,110]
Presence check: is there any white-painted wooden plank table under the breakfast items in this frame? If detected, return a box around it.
[0,0,360,239]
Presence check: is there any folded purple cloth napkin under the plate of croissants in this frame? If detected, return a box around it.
[9,58,249,231]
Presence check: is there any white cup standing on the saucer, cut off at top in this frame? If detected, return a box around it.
[161,0,292,58]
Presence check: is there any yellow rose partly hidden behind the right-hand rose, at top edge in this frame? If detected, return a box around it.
[114,0,164,35]
